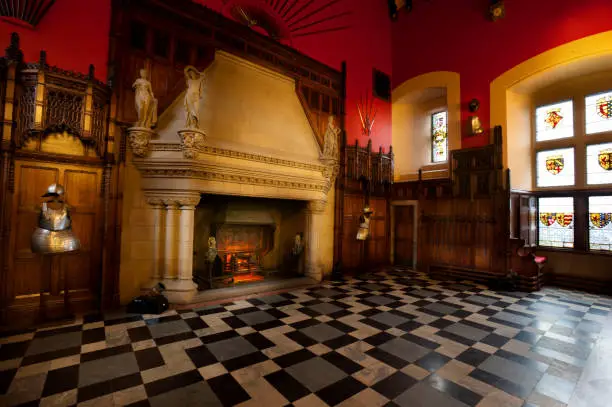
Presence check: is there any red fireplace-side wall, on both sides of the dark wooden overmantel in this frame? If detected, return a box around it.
[0,0,392,149]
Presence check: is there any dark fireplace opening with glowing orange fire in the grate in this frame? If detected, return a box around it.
[194,195,305,289]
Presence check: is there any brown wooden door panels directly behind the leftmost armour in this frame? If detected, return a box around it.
[6,161,102,324]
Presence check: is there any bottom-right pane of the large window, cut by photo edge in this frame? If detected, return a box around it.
[589,196,612,252]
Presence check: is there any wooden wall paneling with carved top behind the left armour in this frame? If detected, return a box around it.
[0,35,113,325]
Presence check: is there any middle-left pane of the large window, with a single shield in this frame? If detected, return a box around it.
[536,148,574,187]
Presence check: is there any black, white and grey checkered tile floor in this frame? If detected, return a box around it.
[0,269,612,407]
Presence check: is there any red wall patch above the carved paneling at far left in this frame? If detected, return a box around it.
[0,0,110,80]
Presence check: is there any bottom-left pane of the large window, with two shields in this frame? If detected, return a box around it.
[538,197,574,248]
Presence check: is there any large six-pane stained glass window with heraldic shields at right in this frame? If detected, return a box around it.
[532,88,612,252]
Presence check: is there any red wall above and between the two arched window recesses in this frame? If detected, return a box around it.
[392,0,612,147]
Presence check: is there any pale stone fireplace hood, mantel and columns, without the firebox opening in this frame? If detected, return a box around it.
[126,52,338,303]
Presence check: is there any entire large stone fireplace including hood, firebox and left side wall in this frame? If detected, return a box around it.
[122,51,338,303]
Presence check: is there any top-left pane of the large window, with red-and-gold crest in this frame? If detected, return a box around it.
[536,100,574,141]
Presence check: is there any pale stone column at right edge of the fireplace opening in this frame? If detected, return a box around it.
[306,200,326,281]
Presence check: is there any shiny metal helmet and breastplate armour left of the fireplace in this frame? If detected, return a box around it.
[32,184,81,254]
